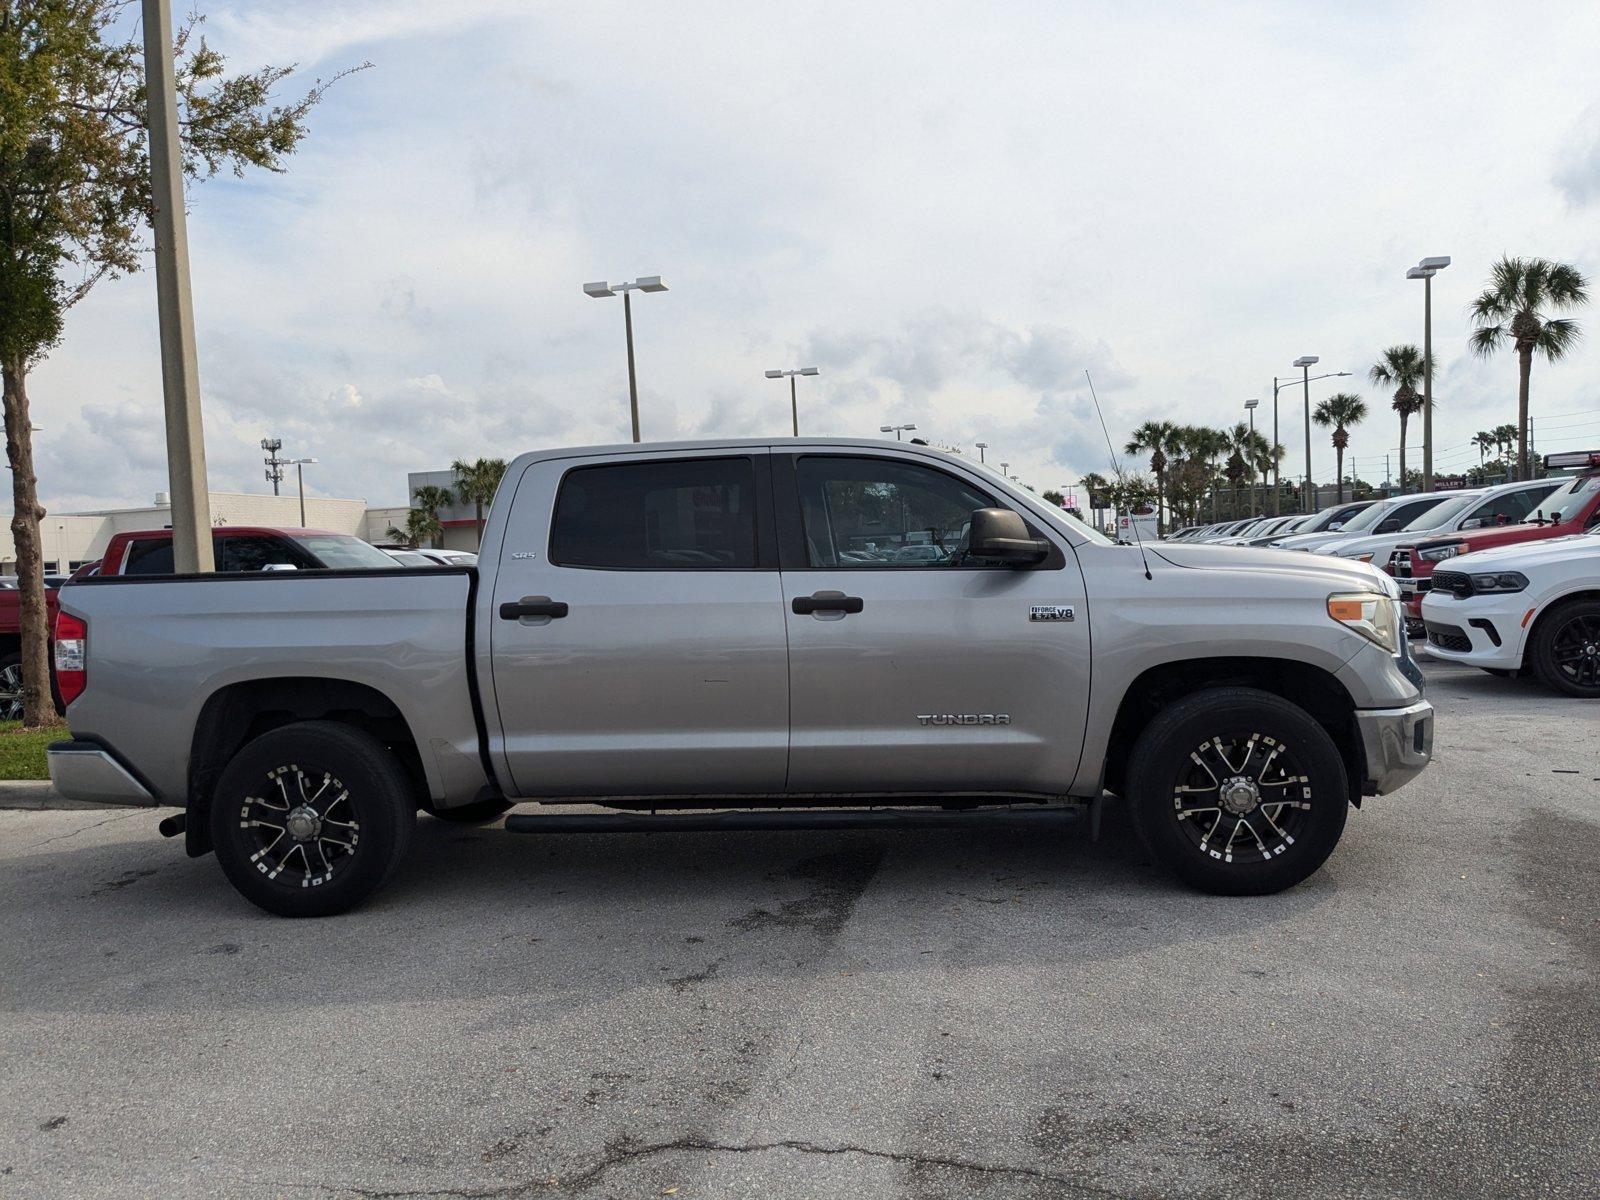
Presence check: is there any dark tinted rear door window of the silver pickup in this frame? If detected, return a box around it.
[550,458,755,571]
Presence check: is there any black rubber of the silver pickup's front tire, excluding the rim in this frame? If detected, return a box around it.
[1126,688,1349,896]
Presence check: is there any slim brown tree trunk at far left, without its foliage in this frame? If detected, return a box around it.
[0,357,56,728]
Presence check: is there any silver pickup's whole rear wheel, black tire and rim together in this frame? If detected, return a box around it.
[211,722,416,917]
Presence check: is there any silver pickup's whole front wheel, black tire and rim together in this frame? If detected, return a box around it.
[1126,688,1350,896]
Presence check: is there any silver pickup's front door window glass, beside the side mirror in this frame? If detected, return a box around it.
[795,456,995,568]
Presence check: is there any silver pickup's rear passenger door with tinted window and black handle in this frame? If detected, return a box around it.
[488,450,789,795]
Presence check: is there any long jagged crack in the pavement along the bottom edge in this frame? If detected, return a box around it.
[318,1136,1118,1200]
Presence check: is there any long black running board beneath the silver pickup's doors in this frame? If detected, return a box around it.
[506,805,1082,834]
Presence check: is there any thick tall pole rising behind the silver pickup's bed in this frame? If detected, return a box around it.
[142,0,216,574]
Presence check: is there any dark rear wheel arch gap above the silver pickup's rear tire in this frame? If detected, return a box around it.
[184,675,429,858]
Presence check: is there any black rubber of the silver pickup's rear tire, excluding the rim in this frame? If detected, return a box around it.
[211,722,416,917]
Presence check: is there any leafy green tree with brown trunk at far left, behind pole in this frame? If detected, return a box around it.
[0,0,356,725]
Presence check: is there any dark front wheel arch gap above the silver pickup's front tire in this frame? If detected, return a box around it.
[1104,658,1366,808]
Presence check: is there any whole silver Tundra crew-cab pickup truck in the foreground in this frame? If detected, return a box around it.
[50,438,1434,915]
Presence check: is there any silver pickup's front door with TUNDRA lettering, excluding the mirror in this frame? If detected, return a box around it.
[774,451,1090,794]
